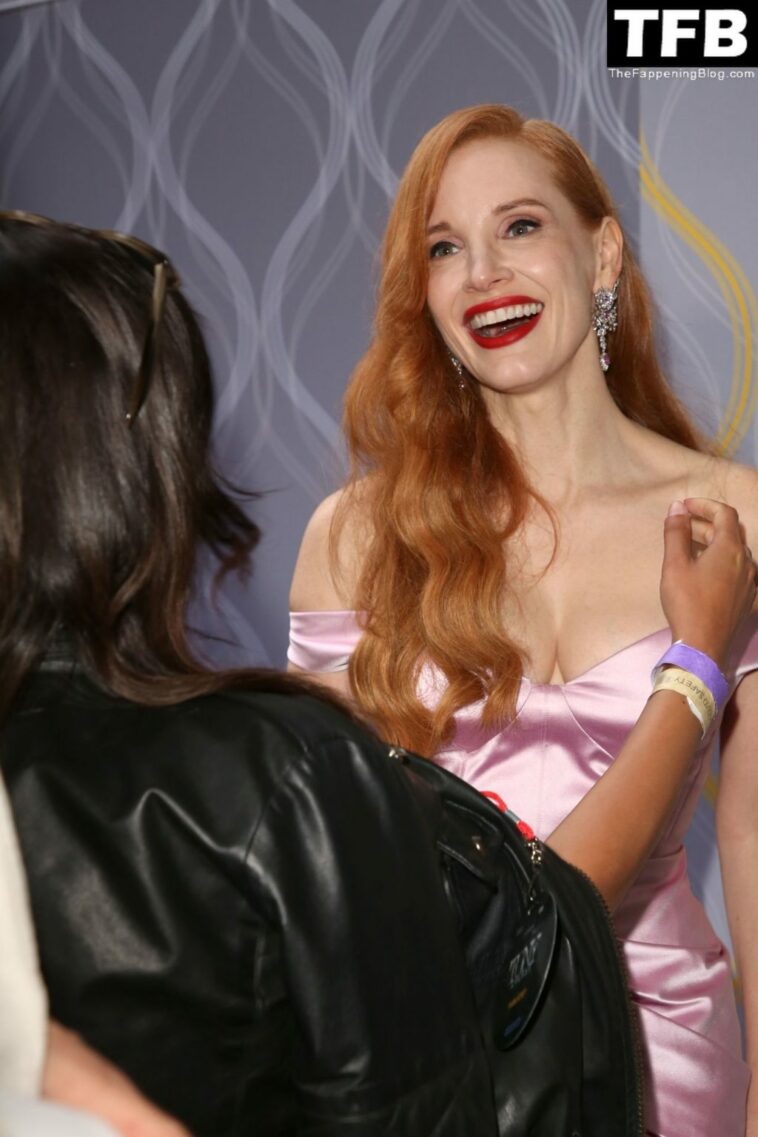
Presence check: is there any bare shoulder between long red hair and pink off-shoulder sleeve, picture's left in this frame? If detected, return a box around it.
[290,484,368,612]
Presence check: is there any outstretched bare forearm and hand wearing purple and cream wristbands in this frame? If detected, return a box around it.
[548,498,756,908]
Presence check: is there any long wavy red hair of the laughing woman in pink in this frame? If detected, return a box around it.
[332,105,701,755]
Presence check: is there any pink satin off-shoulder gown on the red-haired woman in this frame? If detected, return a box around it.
[289,612,758,1137]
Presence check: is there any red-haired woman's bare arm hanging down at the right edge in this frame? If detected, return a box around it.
[716,672,758,1137]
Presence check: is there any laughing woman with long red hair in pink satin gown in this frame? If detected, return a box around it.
[290,106,758,1137]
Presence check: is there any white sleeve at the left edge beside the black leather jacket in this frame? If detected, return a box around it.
[0,778,48,1094]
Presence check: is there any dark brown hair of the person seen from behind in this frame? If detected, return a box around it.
[0,216,334,715]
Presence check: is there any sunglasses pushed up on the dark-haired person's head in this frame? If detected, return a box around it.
[0,209,181,430]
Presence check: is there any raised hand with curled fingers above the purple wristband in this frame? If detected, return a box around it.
[660,498,756,667]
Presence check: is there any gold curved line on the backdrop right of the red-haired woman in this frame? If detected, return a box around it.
[640,133,758,455]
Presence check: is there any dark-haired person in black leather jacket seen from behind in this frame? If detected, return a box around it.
[0,214,497,1137]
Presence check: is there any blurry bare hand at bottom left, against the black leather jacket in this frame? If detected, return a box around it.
[42,1022,190,1137]
